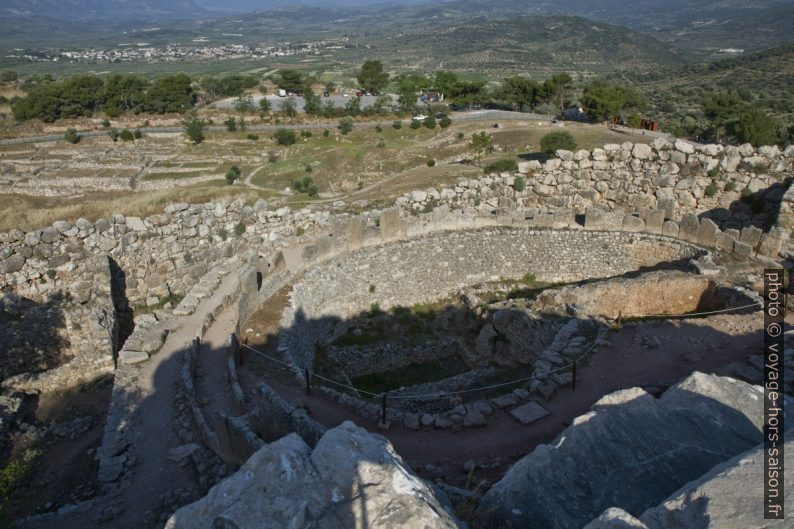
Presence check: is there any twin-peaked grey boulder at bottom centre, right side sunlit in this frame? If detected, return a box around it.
[166,422,459,529]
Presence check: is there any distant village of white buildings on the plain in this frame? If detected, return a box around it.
[6,35,358,63]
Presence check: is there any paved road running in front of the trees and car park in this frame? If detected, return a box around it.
[0,110,553,145]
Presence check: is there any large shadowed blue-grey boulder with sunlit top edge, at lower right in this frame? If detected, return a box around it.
[476,373,763,529]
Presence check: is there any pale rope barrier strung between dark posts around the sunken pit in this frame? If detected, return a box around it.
[240,302,763,400]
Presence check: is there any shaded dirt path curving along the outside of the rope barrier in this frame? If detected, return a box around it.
[244,306,763,485]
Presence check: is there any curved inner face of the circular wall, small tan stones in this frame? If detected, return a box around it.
[281,228,704,368]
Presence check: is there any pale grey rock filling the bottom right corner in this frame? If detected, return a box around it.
[585,430,794,529]
